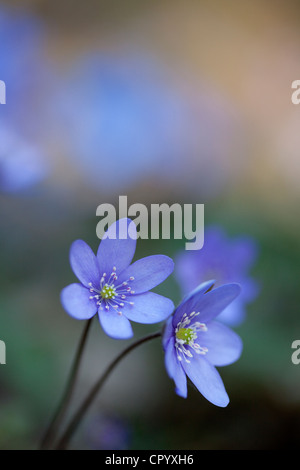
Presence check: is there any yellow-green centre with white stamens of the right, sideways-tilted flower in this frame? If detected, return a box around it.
[175,312,208,363]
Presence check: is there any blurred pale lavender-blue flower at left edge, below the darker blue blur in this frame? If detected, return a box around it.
[0,121,48,193]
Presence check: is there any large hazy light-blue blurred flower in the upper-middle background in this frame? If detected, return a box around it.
[61,55,188,193]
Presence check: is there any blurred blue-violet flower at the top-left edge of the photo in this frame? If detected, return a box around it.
[0,5,49,131]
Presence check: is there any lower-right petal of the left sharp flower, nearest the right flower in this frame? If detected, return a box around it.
[122,292,174,324]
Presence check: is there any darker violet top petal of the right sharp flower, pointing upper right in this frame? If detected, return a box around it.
[173,284,241,326]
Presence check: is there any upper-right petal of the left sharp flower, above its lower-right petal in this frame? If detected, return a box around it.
[119,255,174,294]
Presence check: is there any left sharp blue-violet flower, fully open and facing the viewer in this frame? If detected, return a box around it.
[61,219,174,339]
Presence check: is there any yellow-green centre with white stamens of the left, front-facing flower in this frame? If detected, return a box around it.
[89,267,135,315]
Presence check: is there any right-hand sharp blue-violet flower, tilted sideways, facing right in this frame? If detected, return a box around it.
[163,281,242,407]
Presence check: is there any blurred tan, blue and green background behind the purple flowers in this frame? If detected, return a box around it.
[0,0,300,450]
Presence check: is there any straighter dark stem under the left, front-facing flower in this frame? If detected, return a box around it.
[40,318,92,450]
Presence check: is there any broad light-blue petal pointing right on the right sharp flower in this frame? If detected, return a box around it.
[197,322,243,366]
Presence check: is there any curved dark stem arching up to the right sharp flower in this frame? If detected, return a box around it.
[56,331,161,450]
